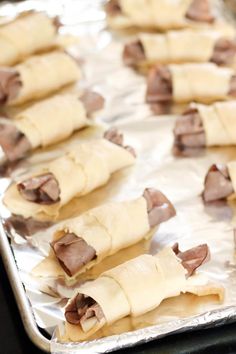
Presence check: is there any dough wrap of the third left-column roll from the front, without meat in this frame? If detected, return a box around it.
[4,139,135,218]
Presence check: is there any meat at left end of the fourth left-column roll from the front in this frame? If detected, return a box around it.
[0,123,32,161]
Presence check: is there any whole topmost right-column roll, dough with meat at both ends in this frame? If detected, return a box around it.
[105,0,214,30]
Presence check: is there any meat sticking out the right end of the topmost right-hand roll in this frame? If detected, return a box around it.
[186,0,214,22]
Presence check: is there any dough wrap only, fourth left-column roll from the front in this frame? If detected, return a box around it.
[15,94,88,148]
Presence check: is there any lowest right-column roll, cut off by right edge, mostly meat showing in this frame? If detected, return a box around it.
[202,161,236,202]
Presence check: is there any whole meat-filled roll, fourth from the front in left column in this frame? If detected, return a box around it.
[0,91,104,161]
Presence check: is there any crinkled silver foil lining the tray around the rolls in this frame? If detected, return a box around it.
[0,0,236,354]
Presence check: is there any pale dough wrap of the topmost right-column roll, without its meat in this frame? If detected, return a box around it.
[108,0,201,30]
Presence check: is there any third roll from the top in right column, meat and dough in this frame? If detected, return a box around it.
[146,63,236,113]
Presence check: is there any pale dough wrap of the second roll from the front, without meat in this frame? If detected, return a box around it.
[55,197,150,279]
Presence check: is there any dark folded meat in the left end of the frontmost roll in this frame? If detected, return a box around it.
[65,294,104,325]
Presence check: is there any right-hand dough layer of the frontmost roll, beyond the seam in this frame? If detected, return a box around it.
[103,248,186,316]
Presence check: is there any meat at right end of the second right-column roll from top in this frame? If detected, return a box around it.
[211,38,236,65]
